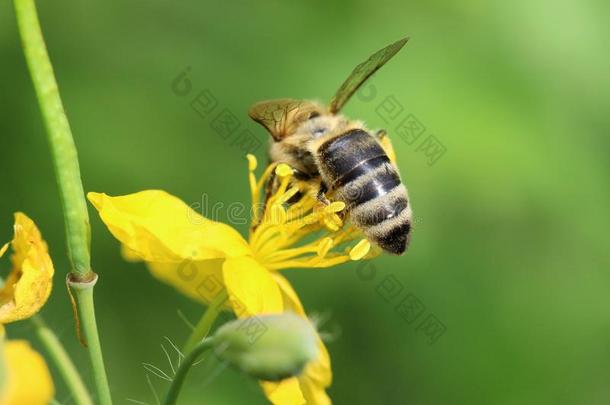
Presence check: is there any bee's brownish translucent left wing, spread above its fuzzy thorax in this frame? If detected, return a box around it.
[248,99,328,141]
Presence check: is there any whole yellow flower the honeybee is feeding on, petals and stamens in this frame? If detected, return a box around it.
[88,155,378,405]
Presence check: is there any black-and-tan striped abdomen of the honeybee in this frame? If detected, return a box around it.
[316,129,411,254]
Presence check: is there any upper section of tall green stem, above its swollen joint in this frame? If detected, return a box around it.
[14,0,93,280]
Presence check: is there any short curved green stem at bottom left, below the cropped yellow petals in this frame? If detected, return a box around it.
[30,315,93,405]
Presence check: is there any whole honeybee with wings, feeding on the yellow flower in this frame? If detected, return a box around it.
[249,38,412,255]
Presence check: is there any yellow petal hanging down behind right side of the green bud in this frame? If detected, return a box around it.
[273,273,332,405]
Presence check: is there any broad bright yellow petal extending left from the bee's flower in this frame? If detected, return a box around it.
[87,190,250,263]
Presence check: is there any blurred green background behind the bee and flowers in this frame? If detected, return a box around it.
[0,0,610,405]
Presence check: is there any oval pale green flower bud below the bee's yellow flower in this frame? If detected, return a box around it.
[213,312,319,381]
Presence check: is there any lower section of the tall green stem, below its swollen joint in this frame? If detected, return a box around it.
[68,273,112,405]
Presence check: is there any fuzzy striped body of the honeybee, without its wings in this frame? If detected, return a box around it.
[270,112,411,254]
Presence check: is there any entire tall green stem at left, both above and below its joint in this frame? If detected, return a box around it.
[13,0,111,405]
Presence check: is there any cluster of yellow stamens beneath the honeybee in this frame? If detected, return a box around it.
[248,155,379,270]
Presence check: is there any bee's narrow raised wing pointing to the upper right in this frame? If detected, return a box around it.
[330,37,409,114]
